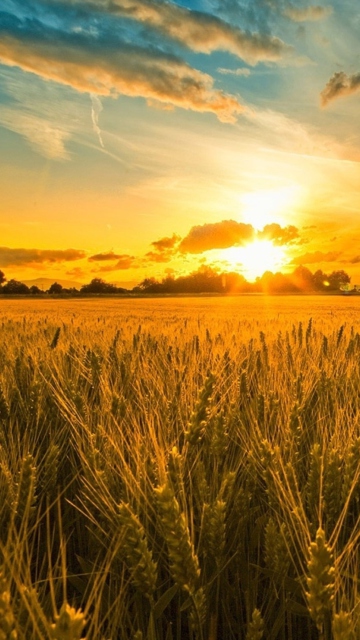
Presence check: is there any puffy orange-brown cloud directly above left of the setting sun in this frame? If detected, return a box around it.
[179,220,255,253]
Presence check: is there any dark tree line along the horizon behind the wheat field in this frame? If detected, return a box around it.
[0,266,350,296]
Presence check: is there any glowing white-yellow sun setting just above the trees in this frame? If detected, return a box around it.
[222,240,288,282]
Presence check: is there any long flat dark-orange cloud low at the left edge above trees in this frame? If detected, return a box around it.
[0,247,86,267]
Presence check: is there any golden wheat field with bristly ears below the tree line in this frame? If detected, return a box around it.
[0,296,360,640]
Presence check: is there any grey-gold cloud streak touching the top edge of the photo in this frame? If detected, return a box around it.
[66,0,292,64]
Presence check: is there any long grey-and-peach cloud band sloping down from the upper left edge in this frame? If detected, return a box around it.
[0,14,244,122]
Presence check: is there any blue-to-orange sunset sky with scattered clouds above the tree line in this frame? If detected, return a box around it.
[0,0,360,286]
